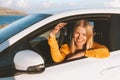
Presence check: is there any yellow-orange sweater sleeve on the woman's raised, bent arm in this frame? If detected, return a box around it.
[48,36,69,62]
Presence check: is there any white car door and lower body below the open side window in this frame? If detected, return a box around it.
[0,50,120,80]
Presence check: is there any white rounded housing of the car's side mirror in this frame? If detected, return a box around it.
[14,50,45,70]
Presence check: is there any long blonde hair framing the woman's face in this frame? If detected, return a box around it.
[70,19,93,53]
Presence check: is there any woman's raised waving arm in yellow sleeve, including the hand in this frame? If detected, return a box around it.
[48,23,69,62]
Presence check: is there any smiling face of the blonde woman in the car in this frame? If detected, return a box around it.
[74,27,87,49]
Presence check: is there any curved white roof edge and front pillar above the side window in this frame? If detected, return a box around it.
[0,9,120,52]
